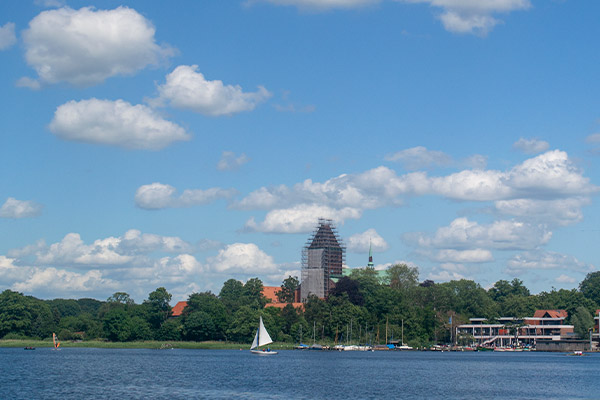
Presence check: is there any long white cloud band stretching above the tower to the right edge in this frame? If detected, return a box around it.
[235,150,598,209]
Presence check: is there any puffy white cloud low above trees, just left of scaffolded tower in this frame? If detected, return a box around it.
[207,243,277,275]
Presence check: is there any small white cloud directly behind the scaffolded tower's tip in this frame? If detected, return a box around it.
[245,204,362,233]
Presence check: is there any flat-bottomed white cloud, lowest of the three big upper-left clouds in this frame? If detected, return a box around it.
[49,98,190,150]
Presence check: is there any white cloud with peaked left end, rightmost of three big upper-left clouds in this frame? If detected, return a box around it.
[151,65,271,117]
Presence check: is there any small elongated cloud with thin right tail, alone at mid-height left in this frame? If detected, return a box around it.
[135,182,237,210]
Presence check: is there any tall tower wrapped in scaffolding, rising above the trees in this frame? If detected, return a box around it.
[300,218,346,301]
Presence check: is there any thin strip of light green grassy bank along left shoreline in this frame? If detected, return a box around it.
[0,339,294,350]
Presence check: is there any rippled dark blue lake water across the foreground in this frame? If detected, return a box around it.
[0,348,600,399]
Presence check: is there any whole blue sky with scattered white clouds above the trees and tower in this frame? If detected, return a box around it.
[0,0,600,301]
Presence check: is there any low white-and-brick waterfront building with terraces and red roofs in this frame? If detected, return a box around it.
[456,310,574,347]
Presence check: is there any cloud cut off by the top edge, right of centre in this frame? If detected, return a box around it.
[396,0,531,36]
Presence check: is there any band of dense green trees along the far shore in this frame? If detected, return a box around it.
[0,264,600,346]
